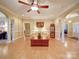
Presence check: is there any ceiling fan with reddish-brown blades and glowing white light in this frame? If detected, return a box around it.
[18,0,49,14]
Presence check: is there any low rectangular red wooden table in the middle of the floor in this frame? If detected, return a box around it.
[31,39,49,47]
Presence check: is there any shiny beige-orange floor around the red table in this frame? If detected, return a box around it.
[0,38,79,59]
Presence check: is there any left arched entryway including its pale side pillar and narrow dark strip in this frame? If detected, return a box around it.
[0,12,13,43]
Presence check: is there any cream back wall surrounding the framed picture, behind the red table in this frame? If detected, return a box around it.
[24,20,53,37]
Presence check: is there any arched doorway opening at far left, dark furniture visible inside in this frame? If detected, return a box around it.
[0,12,9,42]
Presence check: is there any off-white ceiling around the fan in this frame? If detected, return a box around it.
[0,0,79,19]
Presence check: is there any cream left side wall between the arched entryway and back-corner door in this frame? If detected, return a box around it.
[14,18,23,39]
